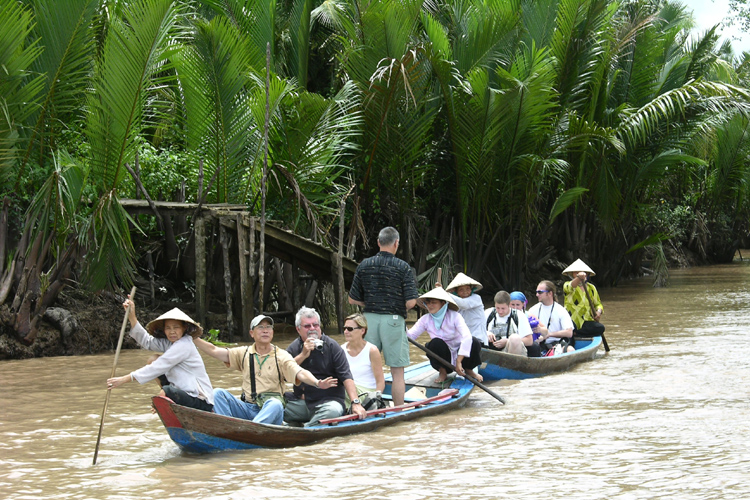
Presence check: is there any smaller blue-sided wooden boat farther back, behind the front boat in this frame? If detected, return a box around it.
[479,337,602,381]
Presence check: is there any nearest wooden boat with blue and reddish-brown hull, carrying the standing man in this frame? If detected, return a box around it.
[152,362,474,453]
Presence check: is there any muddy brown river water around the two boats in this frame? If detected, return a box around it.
[0,262,750,500]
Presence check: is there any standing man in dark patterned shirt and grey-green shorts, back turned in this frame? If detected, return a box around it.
[349,227,419,406]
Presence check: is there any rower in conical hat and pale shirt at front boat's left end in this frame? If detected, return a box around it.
[107,298,214,411]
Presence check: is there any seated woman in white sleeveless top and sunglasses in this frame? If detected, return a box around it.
[341,314,385,394]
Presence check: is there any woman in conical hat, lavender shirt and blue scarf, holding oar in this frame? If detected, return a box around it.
[407,287,482,382]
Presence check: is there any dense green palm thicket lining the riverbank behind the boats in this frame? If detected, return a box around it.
[0,0,750,356]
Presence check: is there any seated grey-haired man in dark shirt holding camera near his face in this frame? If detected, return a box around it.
[284,306,367,427]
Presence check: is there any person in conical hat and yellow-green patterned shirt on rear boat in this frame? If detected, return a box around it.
[563,259,604,337]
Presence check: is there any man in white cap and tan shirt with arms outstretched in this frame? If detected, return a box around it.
[195,314,337,425]
